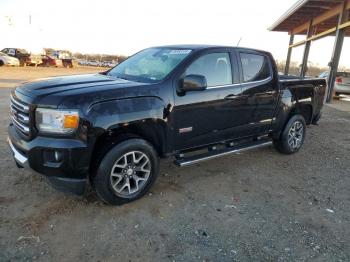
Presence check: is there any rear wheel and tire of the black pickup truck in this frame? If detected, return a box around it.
[273,115,306,154]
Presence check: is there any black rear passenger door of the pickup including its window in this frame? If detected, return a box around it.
[238,50,278,135]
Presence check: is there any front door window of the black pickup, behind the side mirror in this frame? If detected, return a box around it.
[185,53,232,87]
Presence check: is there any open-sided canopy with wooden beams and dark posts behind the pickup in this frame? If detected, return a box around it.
[269,0,350,102]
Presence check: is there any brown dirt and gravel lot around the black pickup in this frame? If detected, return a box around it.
[0,68,350,261]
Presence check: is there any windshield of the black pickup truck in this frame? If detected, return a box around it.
[108,48,191,83]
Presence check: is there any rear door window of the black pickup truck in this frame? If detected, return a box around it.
[240,53,271,82]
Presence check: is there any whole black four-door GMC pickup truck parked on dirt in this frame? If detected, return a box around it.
[8,45,326,204]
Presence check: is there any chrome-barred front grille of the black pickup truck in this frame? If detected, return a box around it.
[10,95,30,136]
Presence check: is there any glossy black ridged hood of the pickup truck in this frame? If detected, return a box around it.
[14,74,162,111]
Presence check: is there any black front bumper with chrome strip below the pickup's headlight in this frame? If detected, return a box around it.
[8,124,91,194]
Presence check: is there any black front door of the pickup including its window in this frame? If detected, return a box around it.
[172,49,246,150]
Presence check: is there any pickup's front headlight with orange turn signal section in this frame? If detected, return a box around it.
[35,108,79,134]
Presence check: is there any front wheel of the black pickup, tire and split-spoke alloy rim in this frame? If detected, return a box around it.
[93,138,159,205]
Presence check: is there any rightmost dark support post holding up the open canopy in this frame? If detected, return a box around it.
[326,1,349,103]
